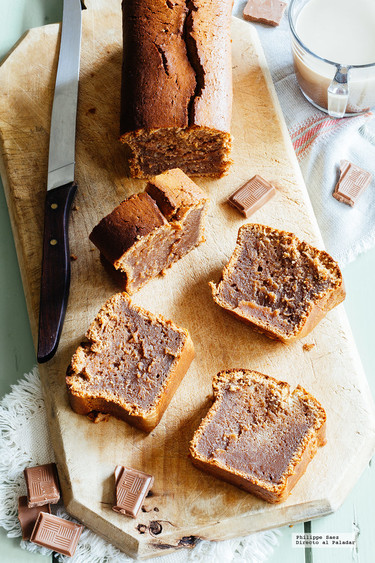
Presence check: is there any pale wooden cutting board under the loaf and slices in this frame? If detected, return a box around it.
[0,0,375,558]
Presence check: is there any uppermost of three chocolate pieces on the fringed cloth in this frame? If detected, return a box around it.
[24,463,60,508]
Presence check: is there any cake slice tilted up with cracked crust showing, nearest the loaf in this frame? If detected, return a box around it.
[90,169,209,294]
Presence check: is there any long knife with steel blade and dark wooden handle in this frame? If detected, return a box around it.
[37,0,82,363]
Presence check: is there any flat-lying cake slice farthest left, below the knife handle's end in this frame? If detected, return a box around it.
[66,293,194,432]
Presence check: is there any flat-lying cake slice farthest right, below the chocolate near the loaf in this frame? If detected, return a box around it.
[210,224,345,342]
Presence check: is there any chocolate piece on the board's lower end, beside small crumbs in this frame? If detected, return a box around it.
[112,465,154,518]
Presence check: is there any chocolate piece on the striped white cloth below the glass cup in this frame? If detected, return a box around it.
[332,160,372,207]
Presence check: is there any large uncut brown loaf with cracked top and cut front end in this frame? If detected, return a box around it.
[120,0,233,178]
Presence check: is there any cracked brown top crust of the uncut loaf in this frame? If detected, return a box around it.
[120,0,233,134]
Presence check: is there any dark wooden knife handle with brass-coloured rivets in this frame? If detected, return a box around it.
[37,182,77,363]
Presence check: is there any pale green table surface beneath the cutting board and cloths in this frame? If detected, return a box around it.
[0,0,375,563]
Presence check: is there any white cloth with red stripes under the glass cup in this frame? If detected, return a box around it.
[233,0,375,266]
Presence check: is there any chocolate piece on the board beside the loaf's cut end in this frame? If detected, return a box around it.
[228,175,276,217]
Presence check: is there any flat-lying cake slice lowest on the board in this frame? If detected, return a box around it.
[190,369,326,503]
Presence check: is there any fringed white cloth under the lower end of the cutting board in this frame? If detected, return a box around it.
[0,368,280,563]
